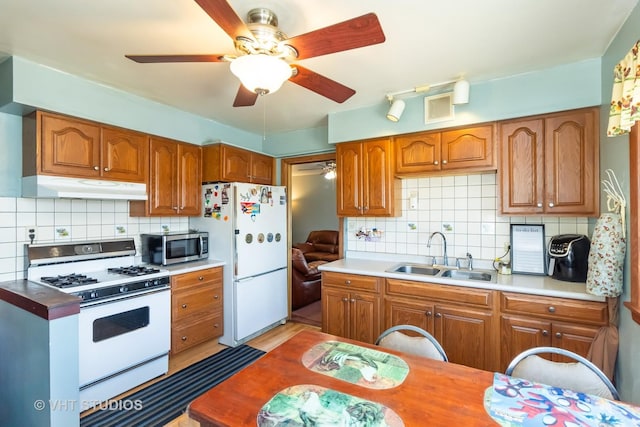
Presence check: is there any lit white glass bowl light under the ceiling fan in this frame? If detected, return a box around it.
[230,53,292,95]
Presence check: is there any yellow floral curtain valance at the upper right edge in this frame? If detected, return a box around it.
[607,40,640,136]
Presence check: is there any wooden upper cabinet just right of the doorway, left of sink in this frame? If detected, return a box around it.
[336,138,400,216]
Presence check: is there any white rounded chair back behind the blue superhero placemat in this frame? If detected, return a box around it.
[505,347,620,400]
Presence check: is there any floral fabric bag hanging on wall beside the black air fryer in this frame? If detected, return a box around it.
[587,169,627,297]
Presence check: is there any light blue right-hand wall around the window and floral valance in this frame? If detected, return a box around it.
[600,0,640,404]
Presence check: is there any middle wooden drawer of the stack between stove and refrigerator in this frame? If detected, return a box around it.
[171,284,222,322]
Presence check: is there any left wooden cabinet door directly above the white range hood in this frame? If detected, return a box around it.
[40,114,100,178]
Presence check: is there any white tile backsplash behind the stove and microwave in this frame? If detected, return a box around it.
[0,197,189,281]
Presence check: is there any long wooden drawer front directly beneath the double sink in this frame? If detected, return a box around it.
[386,279,494,308]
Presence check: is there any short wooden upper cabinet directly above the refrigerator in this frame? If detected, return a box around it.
[202,144,274,185]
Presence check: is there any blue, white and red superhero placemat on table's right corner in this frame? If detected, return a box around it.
[485,373,640,427]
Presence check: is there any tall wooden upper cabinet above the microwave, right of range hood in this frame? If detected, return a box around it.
[129,136,202,216]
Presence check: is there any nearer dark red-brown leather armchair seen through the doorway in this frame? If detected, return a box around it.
[291,248,326,310]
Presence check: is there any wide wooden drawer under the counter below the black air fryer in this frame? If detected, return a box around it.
[501,292,607,325]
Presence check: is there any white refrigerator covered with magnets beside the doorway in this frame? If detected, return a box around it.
[189,183,289,347]
